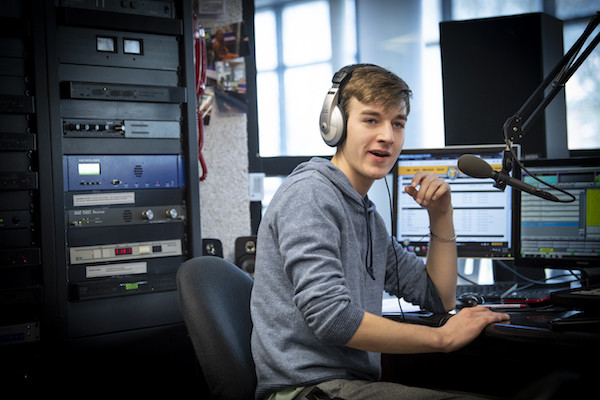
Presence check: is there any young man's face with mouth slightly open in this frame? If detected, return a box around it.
[335,97,407,195]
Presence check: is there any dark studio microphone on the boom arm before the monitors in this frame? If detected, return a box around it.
[458,154,560,201]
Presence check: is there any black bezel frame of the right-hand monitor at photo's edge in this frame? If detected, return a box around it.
[513,157,600,270]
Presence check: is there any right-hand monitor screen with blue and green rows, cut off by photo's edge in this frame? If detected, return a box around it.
[515,158,600,270]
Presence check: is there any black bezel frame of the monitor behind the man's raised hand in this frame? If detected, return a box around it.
[392,144,521,260]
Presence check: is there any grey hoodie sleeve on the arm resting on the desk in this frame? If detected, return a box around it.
[276,173,364,345]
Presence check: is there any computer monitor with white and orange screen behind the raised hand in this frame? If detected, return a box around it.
[392,144,519,260]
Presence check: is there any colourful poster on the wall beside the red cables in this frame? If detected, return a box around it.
[206,22,249,114]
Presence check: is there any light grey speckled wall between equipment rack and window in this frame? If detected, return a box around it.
[195,0,250,261]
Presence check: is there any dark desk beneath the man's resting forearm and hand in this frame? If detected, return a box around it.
[382,308,600,399]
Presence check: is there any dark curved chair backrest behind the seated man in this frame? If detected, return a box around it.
[177,256,256,400]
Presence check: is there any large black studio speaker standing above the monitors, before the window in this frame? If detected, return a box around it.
[440,13,568,159]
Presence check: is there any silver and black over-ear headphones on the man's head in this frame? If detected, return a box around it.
[319,64,381,147]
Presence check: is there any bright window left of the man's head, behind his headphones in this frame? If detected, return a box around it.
[254,0,356,156]
